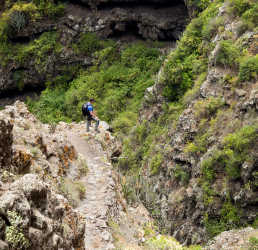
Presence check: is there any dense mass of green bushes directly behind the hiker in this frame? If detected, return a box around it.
[28,41,162,126]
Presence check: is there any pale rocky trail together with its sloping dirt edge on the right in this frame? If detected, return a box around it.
[56,122,153,250]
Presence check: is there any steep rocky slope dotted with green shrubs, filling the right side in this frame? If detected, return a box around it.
[119,1,258,245]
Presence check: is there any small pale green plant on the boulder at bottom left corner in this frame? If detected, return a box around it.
[5,211,29,250]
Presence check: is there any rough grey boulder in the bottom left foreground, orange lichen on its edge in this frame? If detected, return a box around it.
[0,174,85,250]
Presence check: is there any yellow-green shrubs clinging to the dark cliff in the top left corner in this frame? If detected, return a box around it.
[0,0,66,66]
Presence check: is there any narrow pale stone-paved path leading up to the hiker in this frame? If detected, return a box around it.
[67,133,115,250]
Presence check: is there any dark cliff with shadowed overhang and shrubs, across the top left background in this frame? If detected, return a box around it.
[0,1,188,93]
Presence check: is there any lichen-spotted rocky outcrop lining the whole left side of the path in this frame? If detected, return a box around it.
[0,101,87,250]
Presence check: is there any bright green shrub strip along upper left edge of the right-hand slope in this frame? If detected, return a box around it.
[162,1,220,100]
